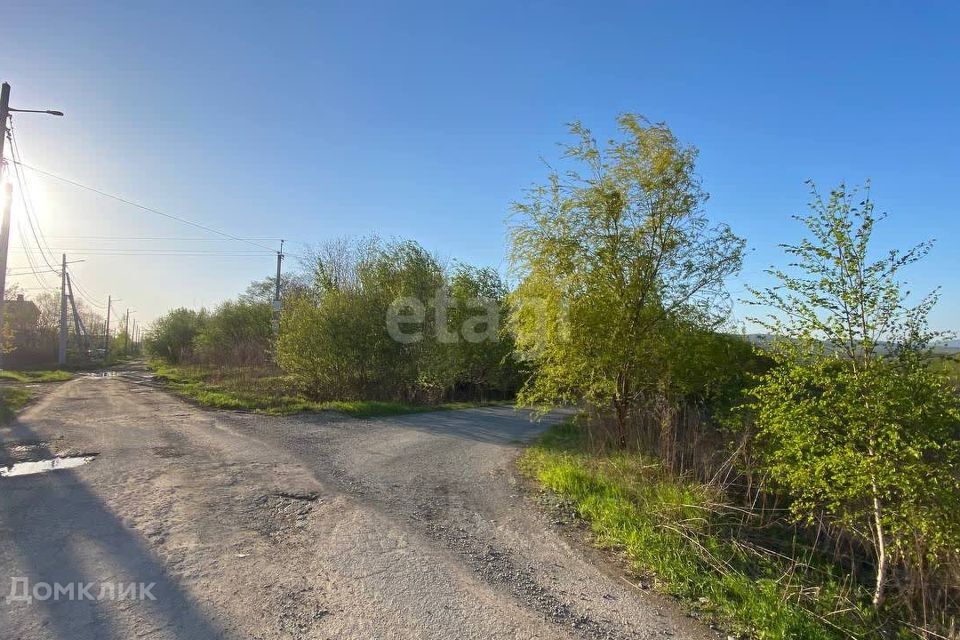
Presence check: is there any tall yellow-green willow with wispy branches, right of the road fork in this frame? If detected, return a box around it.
[511,114,744,446]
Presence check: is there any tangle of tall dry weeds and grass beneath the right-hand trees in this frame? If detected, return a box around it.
[572,396,960,640]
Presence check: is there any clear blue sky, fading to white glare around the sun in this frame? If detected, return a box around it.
[0,1,960,329]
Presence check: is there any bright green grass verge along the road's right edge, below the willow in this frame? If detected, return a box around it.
[519,422,870,639]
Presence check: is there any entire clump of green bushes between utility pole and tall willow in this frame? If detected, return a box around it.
[278,239,516,401]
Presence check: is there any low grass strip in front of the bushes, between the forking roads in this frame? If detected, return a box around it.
[150,362,502,418]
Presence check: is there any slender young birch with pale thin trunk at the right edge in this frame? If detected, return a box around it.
[752,184,960,607]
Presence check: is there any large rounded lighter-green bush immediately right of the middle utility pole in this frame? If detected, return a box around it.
[278,241,445,400]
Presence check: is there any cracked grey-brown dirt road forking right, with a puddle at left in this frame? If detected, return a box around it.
[0,373,711,640]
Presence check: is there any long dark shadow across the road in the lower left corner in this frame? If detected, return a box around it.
[0,423,230,640]
